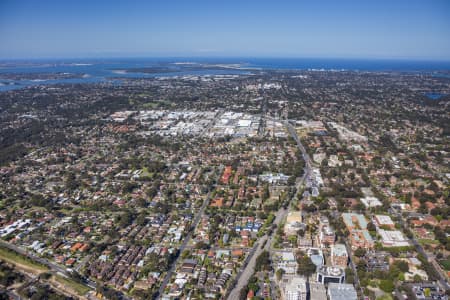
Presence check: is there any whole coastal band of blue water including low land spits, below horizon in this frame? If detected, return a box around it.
[0,58,450,91]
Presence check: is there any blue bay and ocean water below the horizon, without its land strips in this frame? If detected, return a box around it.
[0,57,450,91]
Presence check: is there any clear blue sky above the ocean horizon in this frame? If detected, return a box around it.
[0,0,450,61]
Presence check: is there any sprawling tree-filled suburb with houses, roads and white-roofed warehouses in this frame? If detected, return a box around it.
[0,70,450,300]
